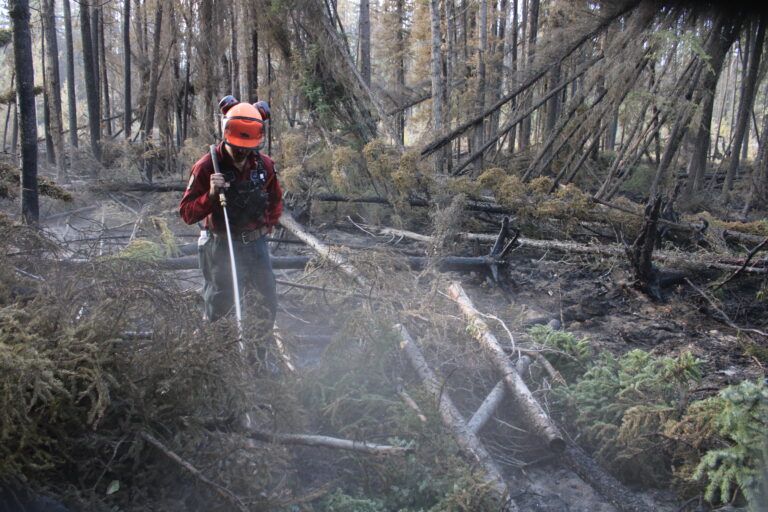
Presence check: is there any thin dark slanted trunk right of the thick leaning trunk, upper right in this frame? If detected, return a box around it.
[722,13,768,201]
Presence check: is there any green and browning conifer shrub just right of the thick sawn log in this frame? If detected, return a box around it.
[559,350,701,486]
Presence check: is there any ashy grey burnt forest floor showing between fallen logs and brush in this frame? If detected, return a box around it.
[3,161,768,512]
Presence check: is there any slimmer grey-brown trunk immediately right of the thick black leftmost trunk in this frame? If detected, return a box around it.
[42,0,66,181]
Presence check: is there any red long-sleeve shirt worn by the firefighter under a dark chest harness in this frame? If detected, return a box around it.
[179,142,283,233]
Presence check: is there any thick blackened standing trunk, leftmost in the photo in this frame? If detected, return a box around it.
[8,0,40,225]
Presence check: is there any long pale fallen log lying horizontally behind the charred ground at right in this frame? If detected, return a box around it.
[379,228,768,274]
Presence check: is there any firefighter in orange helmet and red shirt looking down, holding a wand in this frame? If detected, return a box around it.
[179,96,283,336]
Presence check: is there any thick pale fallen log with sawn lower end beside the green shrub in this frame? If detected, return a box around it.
[448,282,565,452]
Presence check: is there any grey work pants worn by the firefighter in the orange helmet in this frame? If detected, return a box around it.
[198,230,277,334]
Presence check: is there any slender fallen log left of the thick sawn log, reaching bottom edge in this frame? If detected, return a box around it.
[395,325,518,510]
